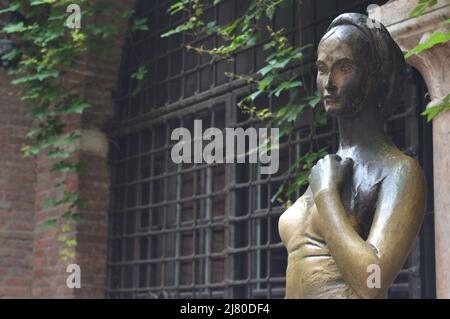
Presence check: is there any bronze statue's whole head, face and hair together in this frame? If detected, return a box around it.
[317,13,406,117]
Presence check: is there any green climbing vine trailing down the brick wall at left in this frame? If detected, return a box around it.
[0,0,132,258]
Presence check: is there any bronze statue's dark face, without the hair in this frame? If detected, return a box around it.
[317,26,369,117]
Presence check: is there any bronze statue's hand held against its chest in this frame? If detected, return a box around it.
[309,155,353,195]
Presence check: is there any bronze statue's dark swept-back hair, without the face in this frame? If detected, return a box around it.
[327,13,407,118]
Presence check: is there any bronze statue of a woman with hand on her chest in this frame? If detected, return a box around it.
[279,13,425,298]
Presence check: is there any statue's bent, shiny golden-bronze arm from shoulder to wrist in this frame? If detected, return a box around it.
[314,159,425,298]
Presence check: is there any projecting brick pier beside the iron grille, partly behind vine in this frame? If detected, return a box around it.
[32,0,134,298]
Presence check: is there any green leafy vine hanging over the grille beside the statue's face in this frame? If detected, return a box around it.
[162,0,327,205]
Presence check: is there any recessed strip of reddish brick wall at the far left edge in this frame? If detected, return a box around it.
[0,70,35,298]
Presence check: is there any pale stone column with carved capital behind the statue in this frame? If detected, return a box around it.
[369,0,450,298]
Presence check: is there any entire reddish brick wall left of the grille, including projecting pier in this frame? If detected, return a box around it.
[0,0,134,298]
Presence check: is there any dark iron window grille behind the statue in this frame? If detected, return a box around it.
[106,0,434,298]
